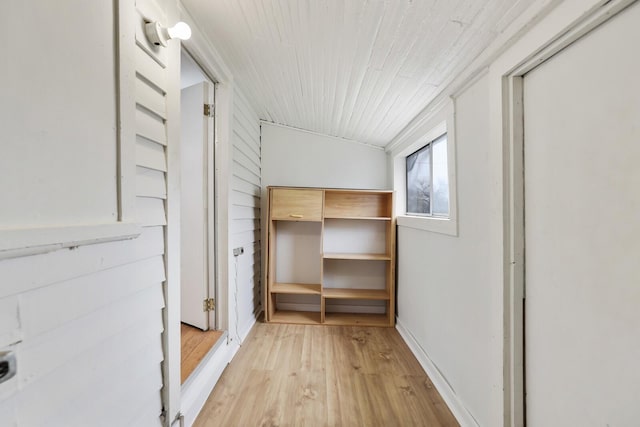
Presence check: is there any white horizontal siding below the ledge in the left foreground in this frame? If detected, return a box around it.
[0,231,164,426]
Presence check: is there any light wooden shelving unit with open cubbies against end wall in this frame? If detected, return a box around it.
[264,187,395,326]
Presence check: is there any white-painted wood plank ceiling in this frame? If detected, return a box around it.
[183,0,530,146]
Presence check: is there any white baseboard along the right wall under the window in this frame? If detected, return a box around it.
[396,319,479,427]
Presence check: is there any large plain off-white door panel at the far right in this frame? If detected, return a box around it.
[524,3,640,427]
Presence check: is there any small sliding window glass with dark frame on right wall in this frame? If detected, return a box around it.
[406,133,449,217]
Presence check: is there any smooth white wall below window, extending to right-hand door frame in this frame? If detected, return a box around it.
[398,76,502,426]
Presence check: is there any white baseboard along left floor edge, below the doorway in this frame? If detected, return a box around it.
[180,332,240,427]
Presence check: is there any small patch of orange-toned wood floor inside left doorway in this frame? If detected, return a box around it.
[180,323,223,384]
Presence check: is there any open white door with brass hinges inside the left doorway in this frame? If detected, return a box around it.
[180,81,215,330]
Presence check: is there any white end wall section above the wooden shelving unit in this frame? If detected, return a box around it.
[261,122,387,189]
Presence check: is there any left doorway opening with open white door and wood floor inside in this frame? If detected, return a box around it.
[180,49,224,384]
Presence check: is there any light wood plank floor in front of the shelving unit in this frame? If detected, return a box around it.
[194,323,458,427]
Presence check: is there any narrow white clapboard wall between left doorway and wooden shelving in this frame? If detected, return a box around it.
[229,90,261,336]
